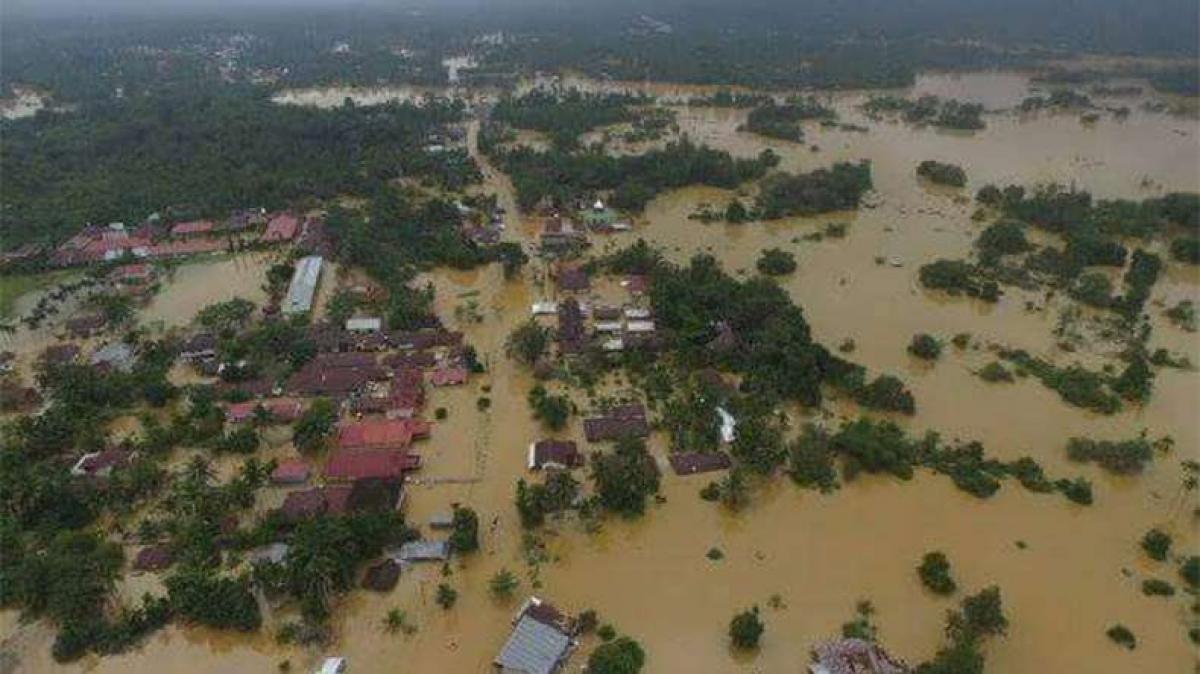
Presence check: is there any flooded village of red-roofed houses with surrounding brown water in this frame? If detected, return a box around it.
[0,39,1200,674]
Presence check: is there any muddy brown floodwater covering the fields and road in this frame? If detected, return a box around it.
[0,73,1200,674]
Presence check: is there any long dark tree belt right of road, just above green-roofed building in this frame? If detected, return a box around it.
[480,131,779,211]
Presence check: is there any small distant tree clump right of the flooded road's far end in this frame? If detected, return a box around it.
[491,89,653,148]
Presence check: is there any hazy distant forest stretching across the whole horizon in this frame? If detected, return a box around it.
[0,0,1200,102]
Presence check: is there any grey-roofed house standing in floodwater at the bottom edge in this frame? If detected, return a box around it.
[492,597,577,674]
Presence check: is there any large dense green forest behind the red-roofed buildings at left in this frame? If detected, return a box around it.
[0,86,478,245]
